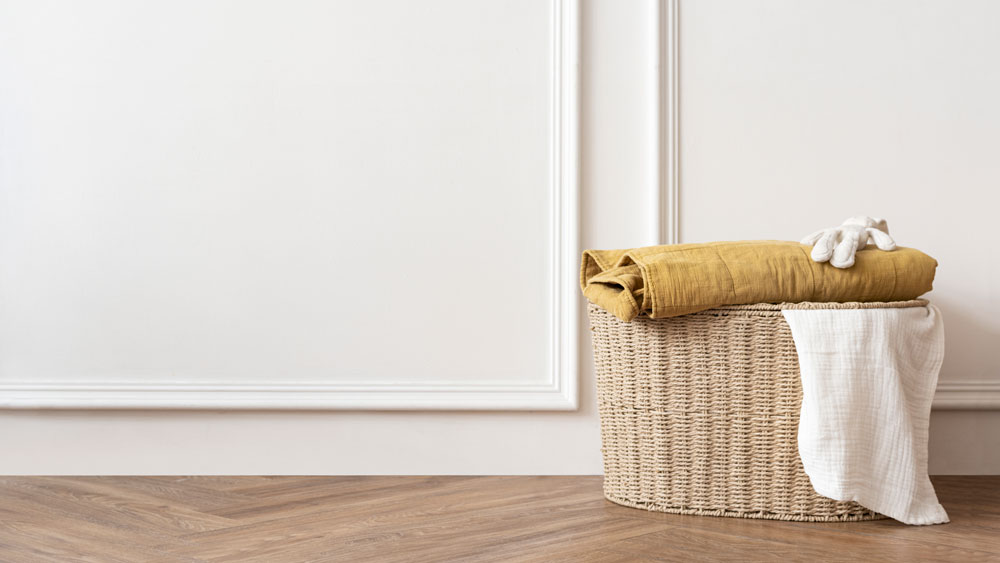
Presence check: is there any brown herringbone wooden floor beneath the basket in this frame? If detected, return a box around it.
[0,477,1000,563]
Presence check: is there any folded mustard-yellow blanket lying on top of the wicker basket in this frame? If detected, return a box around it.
[580,240,937,321]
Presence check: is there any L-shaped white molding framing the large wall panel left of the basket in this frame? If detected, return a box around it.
[0,0,580,410]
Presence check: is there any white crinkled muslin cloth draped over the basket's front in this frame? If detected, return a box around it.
[784,305,948,524]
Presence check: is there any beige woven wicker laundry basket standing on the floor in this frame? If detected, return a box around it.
[589,300,927,521]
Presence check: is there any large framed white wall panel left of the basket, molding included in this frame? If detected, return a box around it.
[0,0,578,408]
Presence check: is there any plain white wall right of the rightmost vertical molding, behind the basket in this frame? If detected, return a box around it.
[680,0,1000,473]
